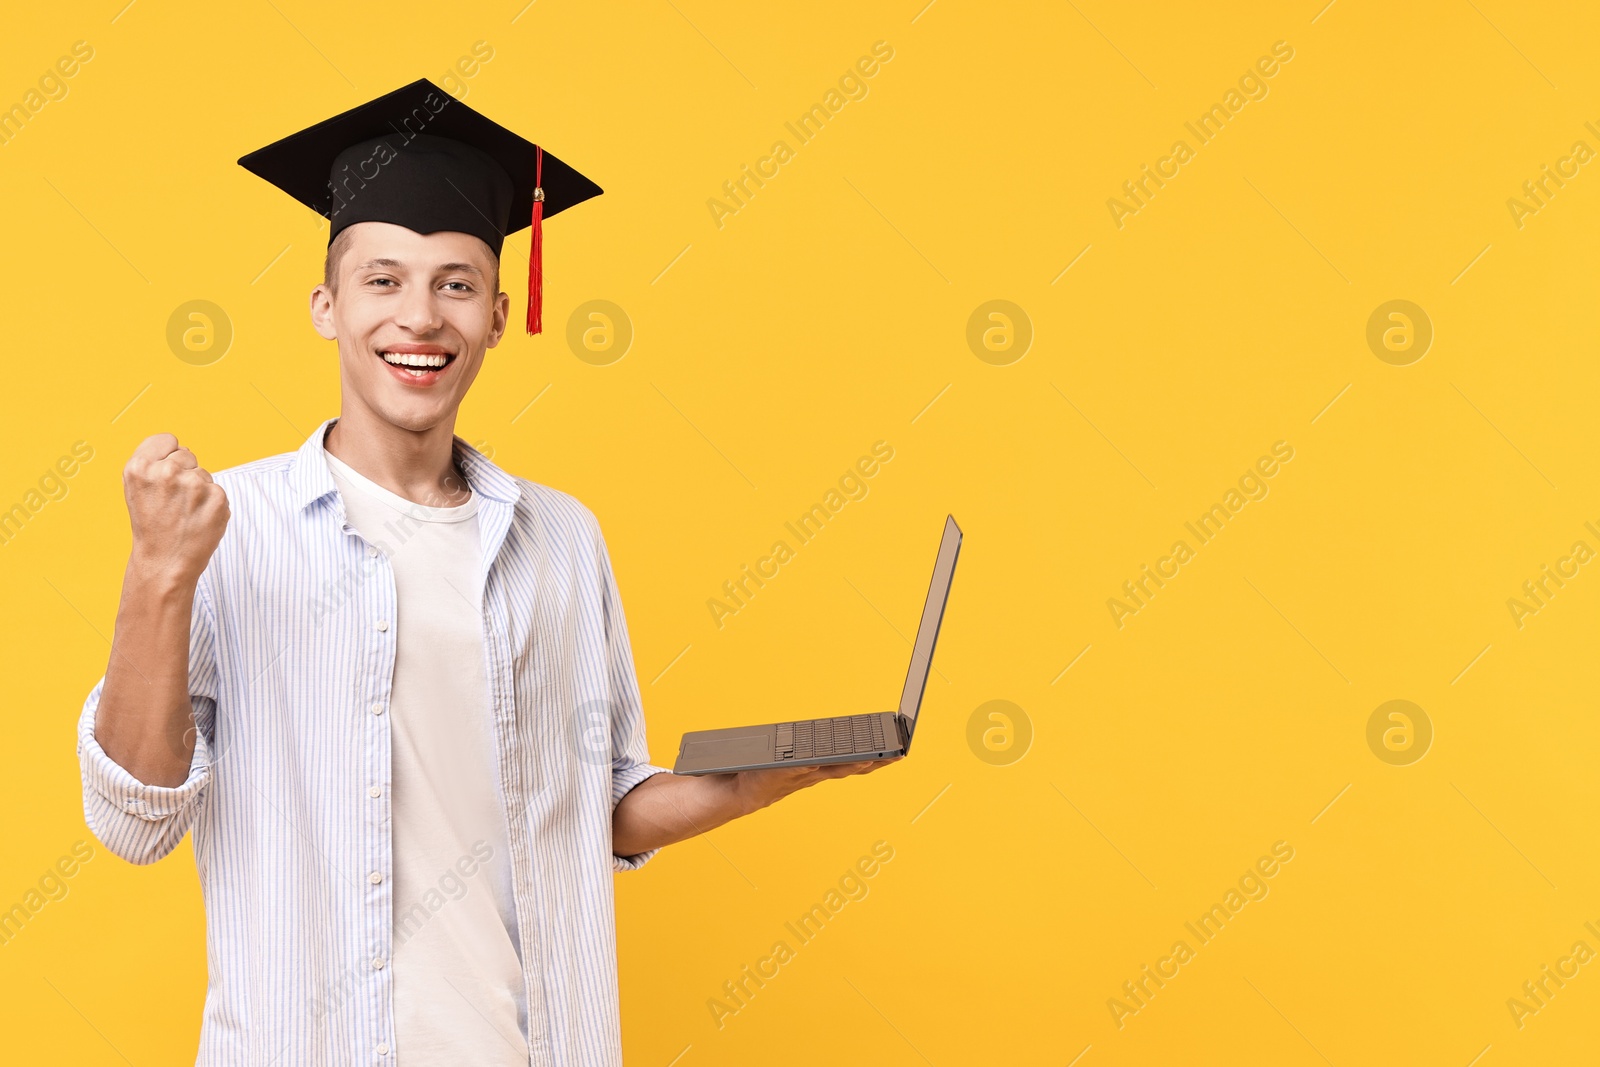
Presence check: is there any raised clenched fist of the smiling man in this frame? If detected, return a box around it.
[122,434,230,584]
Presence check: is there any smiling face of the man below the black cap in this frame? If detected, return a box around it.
[310,222,510,430]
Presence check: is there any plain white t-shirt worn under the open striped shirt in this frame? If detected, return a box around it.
[323,448,528,1067]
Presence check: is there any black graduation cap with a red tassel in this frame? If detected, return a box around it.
[238,78,602,334]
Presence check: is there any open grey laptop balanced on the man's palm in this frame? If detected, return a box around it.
[672,515,962,774]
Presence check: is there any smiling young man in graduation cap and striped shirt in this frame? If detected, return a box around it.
[78,82,893,1067]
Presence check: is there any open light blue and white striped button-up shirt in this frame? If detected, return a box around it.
[77,419,669,1067]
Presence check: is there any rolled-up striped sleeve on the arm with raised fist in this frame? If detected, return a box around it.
[78,577,218,864]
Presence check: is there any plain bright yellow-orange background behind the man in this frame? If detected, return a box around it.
[0,0,1600,1067]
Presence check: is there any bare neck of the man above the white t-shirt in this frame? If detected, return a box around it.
[323,410,472,507]
